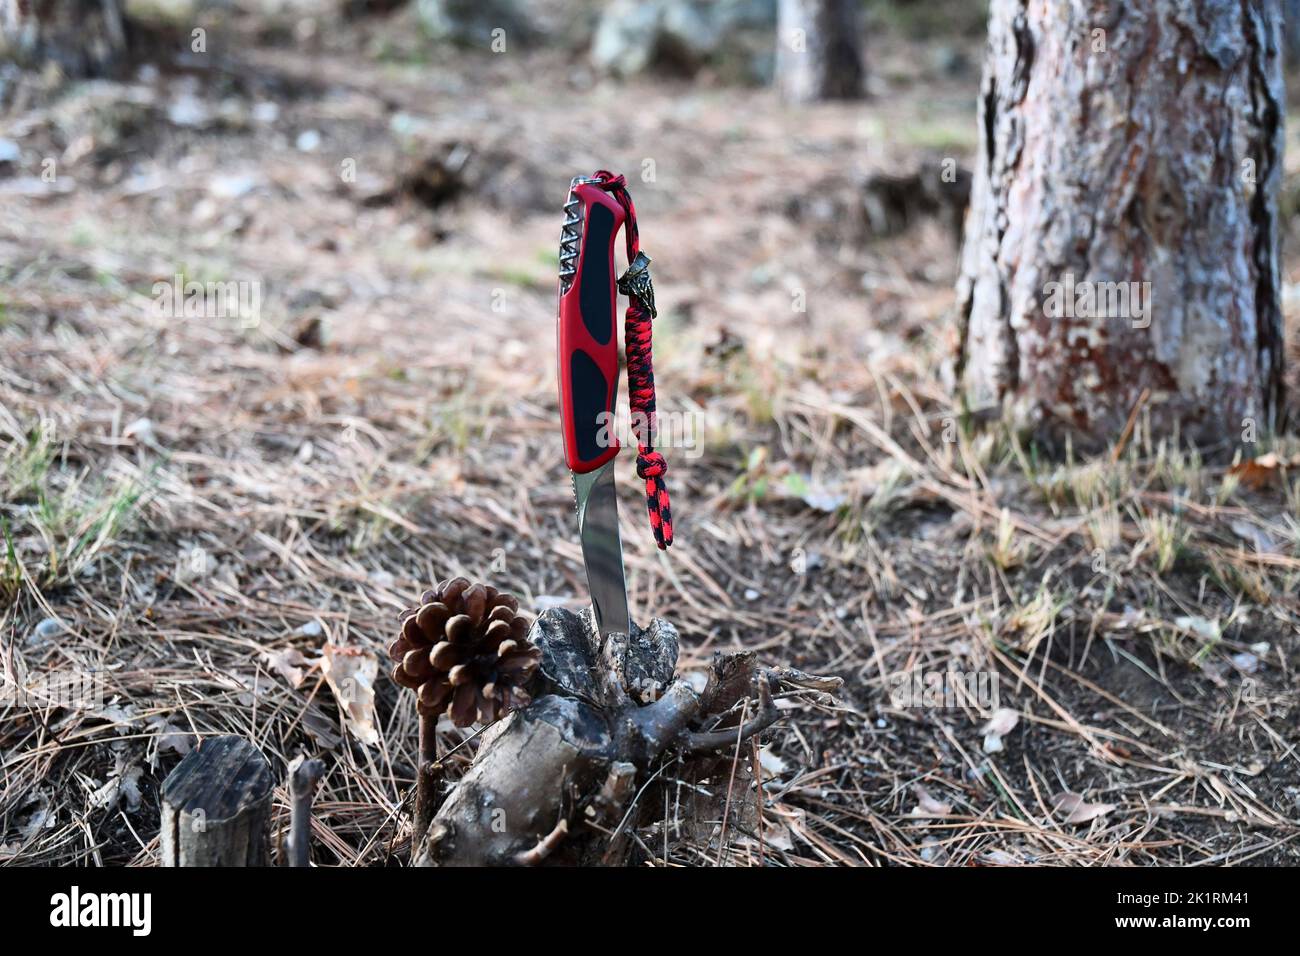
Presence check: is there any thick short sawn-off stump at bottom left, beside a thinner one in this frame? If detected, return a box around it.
[160,736,273,866]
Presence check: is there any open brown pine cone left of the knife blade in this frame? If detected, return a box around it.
[389,578,542,727]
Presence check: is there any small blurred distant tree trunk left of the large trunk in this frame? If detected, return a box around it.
[776,0,865,103]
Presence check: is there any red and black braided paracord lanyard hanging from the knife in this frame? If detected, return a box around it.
[593,169,672,550]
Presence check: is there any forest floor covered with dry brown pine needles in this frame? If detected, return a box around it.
[0,1,1300,865]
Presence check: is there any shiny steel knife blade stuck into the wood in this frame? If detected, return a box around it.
[573,460,631,636]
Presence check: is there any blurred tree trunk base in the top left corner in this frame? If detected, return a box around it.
[0,0,127,77]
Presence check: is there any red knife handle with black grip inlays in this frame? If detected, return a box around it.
[558,185,624,475]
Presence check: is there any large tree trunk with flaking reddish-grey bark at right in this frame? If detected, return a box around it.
[957,0,1284,449]
